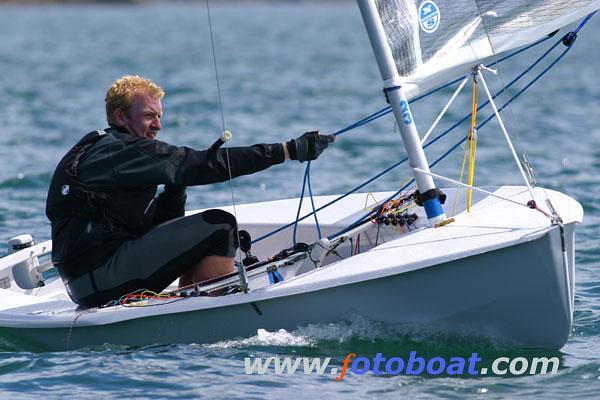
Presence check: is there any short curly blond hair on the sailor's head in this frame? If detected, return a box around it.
[104,75,165,126]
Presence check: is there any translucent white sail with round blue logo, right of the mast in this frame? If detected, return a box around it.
[376,0,600,97]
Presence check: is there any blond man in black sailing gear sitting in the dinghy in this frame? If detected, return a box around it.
[46,75,333,307]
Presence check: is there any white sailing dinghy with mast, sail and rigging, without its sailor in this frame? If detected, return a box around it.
[0,0,600,350]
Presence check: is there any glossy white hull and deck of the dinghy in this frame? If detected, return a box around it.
[0,187,582,350]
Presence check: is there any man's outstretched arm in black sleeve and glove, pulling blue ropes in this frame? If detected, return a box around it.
[80,133,326,188]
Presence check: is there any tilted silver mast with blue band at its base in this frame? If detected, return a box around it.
[357,0,446,224]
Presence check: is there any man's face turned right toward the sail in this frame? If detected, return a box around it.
[115,95,162,140]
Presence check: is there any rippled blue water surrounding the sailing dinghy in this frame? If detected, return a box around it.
[0,3,600,398]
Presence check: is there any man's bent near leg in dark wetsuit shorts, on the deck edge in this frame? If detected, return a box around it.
[68,210,238,306]
